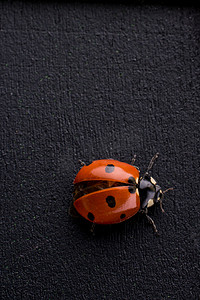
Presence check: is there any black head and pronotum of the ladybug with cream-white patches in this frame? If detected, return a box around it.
[139,174,163,208]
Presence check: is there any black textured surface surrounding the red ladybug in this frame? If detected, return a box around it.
[0,1,200,300]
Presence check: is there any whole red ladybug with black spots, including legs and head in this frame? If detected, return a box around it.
[70,153,171,232]
